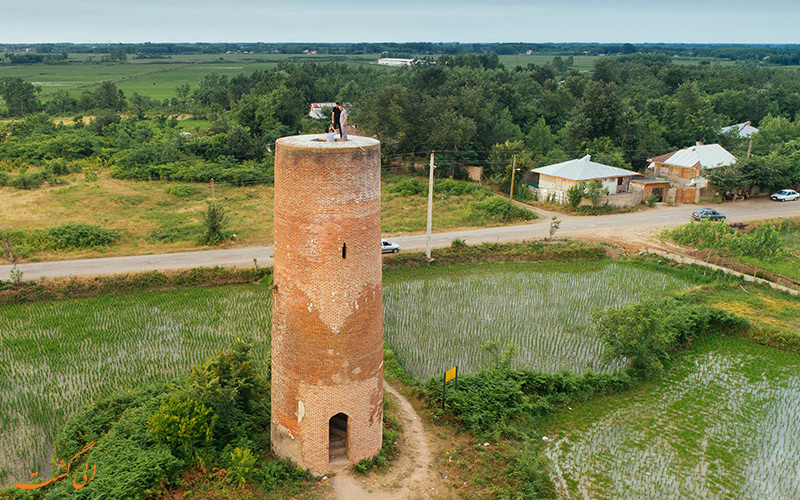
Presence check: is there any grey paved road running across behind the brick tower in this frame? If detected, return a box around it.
[6,199,800,280]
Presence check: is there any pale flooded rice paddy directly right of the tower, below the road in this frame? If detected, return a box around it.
[384,263,686,379]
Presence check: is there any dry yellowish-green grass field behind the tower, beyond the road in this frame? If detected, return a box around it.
[0,171,530,260]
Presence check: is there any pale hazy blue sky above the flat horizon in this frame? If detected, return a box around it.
[0,0,800,43]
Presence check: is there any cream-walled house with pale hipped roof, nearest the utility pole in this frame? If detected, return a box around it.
[531,155,641,206]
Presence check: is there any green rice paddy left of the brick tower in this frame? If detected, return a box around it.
[0,286,272,485]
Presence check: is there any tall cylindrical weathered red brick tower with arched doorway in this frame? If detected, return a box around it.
[271,135,383,474]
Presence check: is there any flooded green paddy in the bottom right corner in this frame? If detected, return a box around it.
[547,337,800,500]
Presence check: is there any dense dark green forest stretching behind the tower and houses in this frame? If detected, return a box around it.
[0,54,800,194]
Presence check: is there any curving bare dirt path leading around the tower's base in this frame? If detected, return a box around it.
[331,384,443,500]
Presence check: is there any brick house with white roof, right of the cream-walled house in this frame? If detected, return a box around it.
[647,142,736,187]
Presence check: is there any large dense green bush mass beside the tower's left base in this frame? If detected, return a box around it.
[43,342,288,500]
